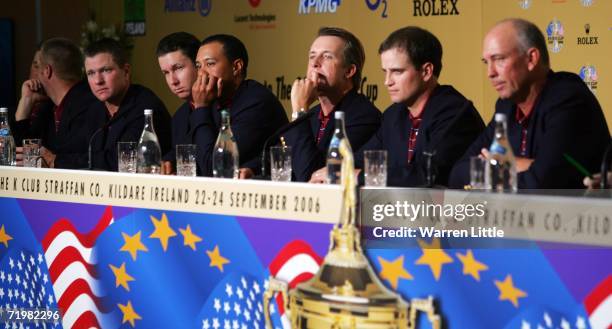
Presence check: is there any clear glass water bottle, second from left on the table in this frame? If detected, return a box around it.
[136,109,161,174]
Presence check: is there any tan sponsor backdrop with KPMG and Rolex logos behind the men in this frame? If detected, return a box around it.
[93,0,612,129]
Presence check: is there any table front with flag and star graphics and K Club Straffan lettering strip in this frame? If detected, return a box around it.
[0,167,612,328]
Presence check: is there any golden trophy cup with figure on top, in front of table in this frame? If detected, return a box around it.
[264,138,440,329]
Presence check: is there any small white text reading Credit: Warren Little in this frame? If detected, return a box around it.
[372,226,504,238]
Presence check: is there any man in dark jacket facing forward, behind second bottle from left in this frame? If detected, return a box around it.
[84,39,171,171]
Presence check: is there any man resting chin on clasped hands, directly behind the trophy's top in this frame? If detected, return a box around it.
[284,27,381,182]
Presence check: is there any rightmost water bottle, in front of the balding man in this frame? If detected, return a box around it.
[485,113,517,192]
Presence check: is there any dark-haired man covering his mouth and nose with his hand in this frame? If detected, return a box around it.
[190,34,287,178]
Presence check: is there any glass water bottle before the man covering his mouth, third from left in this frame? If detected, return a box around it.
[213,110,239,178]
